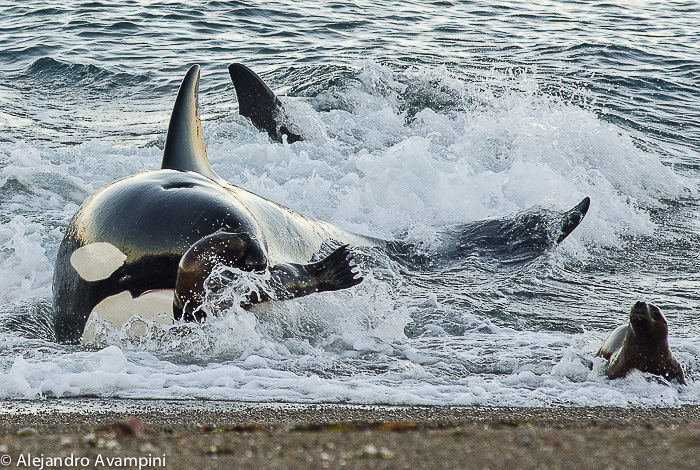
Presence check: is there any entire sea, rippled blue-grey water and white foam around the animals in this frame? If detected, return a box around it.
[0,0,700,406]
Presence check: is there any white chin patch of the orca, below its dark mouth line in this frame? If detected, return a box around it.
[81,289,174,344]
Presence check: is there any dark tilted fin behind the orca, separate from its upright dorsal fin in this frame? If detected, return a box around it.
[228,64,302,144]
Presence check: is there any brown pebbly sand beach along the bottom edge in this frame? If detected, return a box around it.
[0,399,700,469]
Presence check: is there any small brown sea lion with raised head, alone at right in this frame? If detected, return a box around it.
[596,302,685,384]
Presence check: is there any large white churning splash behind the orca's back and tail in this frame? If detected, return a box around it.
[205,64,690,250]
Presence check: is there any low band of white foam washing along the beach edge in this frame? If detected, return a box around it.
[0,328,700,406]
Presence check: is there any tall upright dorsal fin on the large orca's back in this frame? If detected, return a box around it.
[161,65,222,181]
